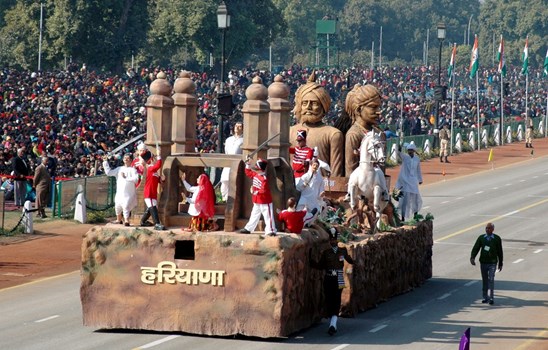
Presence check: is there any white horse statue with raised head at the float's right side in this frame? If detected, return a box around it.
[348,131,390,229]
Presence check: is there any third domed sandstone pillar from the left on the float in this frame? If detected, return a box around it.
[242,77,270,159]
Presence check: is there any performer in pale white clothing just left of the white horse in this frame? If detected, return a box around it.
[297,158,325,227]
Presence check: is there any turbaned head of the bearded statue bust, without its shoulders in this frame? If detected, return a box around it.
[293,72,331,125]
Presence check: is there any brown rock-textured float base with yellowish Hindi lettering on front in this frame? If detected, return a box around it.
[80,222,432,338]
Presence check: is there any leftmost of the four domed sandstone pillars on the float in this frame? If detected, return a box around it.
[145,72,173,160]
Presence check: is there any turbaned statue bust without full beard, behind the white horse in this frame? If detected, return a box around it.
[344,84,386,176]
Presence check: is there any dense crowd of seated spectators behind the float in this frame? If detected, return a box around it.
[0,61,547,177]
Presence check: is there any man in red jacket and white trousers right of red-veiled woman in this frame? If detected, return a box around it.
[240,158,277,236]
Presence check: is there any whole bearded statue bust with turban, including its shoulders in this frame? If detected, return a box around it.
[290,72,344,176]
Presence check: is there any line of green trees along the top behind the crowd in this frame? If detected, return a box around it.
[0,0,548,72]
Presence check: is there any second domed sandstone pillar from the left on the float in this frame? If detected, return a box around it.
[171,71,198,154]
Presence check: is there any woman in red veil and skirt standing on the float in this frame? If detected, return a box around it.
[181,173,215,231]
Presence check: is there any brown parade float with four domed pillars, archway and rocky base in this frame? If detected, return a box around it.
[80,72,433,338]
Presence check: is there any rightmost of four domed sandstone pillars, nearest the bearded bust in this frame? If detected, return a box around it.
[268,75,291,163]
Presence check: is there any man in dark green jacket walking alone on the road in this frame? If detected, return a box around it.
[470,223,502,305]
